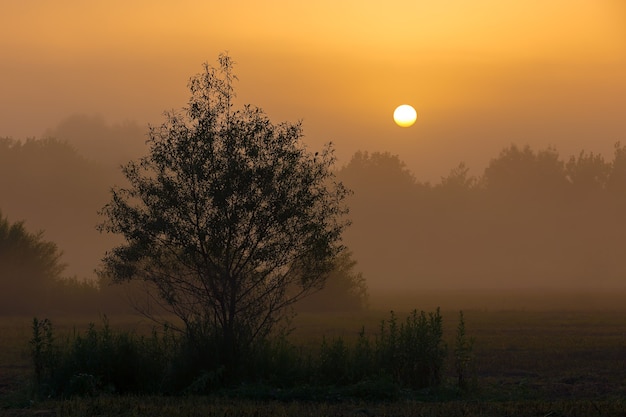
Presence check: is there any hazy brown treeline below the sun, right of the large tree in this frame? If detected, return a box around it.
[340,143,626,289]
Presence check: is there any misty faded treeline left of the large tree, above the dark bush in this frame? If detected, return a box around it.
[0,114,147,281]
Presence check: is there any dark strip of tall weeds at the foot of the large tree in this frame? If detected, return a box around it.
[30,310,456,400]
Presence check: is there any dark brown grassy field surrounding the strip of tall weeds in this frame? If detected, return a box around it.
[0,290,626,417]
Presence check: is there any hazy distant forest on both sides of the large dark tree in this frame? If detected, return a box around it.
[0,118,626,308]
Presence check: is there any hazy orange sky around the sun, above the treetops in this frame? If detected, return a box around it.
[0,0,626,181]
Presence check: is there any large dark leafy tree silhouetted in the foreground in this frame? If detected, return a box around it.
[100,54,349,368]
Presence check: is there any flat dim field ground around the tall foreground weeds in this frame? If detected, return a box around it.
[0,290,626,416]
